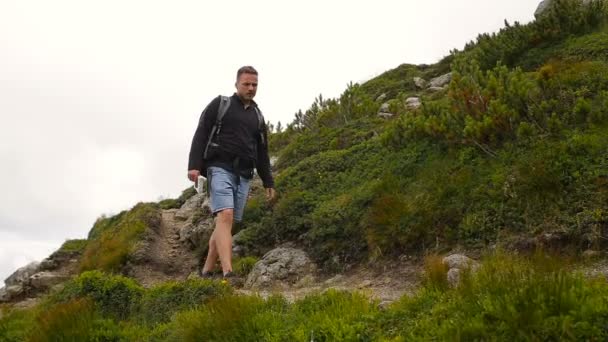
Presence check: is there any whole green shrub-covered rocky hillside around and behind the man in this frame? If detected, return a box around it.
[0,0,608,341]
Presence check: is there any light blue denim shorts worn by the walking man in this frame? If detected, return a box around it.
[207,166,250,222]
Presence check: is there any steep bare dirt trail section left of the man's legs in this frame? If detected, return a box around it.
[131,209,198,287]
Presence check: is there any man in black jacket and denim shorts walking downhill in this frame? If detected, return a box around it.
[188,66,275,279]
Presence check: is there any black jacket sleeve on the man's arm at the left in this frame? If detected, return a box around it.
[188,96,220,172]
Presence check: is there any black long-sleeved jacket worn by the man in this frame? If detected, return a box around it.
[188,94,274,188]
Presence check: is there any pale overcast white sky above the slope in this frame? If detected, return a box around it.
[0,0,540,286]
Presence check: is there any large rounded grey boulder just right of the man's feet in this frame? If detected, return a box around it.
[245,247,316,289]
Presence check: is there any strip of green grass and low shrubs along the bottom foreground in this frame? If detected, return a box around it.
[0,252,608,341]
